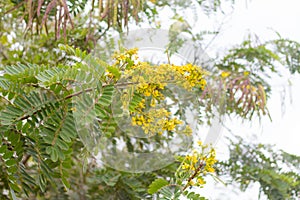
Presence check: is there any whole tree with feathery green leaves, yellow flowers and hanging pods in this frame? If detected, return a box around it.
[0,0,300,199]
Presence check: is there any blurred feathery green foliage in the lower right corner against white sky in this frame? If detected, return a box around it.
[217,137,300,200]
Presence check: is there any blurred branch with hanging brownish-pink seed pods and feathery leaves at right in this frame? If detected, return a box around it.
[206,39,299,119]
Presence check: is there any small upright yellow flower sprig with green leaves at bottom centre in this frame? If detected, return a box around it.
[148,141,217,200]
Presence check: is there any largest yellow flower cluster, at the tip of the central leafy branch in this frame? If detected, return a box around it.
[113,49,206,135]
